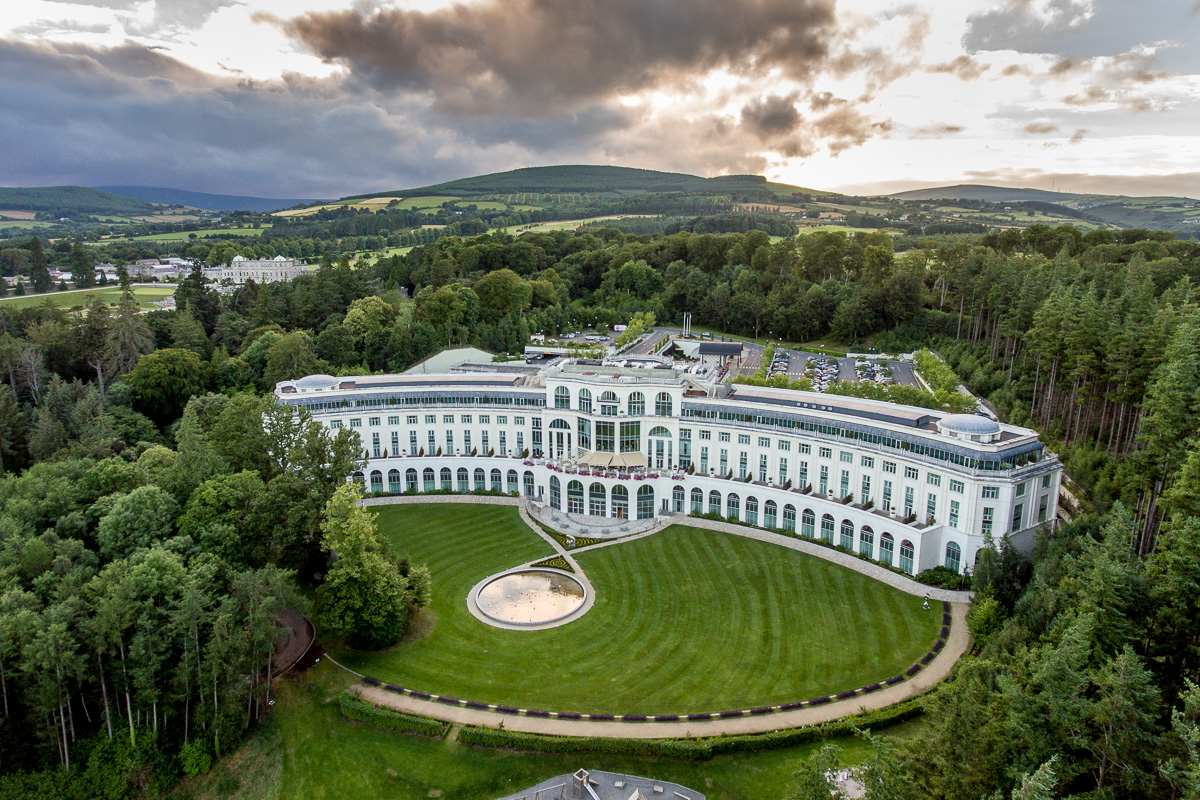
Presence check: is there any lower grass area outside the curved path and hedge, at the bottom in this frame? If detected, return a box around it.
[170,661,922,800]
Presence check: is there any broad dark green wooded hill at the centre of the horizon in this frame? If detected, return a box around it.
[344,164,809,200]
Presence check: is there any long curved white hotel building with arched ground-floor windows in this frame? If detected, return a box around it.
[275,361,1062,573]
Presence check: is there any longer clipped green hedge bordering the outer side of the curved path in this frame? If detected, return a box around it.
[458,698,923,760]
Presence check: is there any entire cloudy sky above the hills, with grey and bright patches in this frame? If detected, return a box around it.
[0,0,1200,197]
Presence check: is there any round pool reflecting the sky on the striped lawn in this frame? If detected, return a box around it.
[474,569,587,627]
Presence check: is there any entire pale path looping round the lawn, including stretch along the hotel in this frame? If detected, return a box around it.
[350,494,971,739]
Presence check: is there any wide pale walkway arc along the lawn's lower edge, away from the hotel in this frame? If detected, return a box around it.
[336,603,971,739]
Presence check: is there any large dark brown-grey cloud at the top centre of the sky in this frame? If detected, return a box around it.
[268,0,836,116]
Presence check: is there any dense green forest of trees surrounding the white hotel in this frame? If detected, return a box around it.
[0,221,1200,800]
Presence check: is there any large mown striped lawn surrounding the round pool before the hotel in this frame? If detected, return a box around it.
[337,505,941,714]
